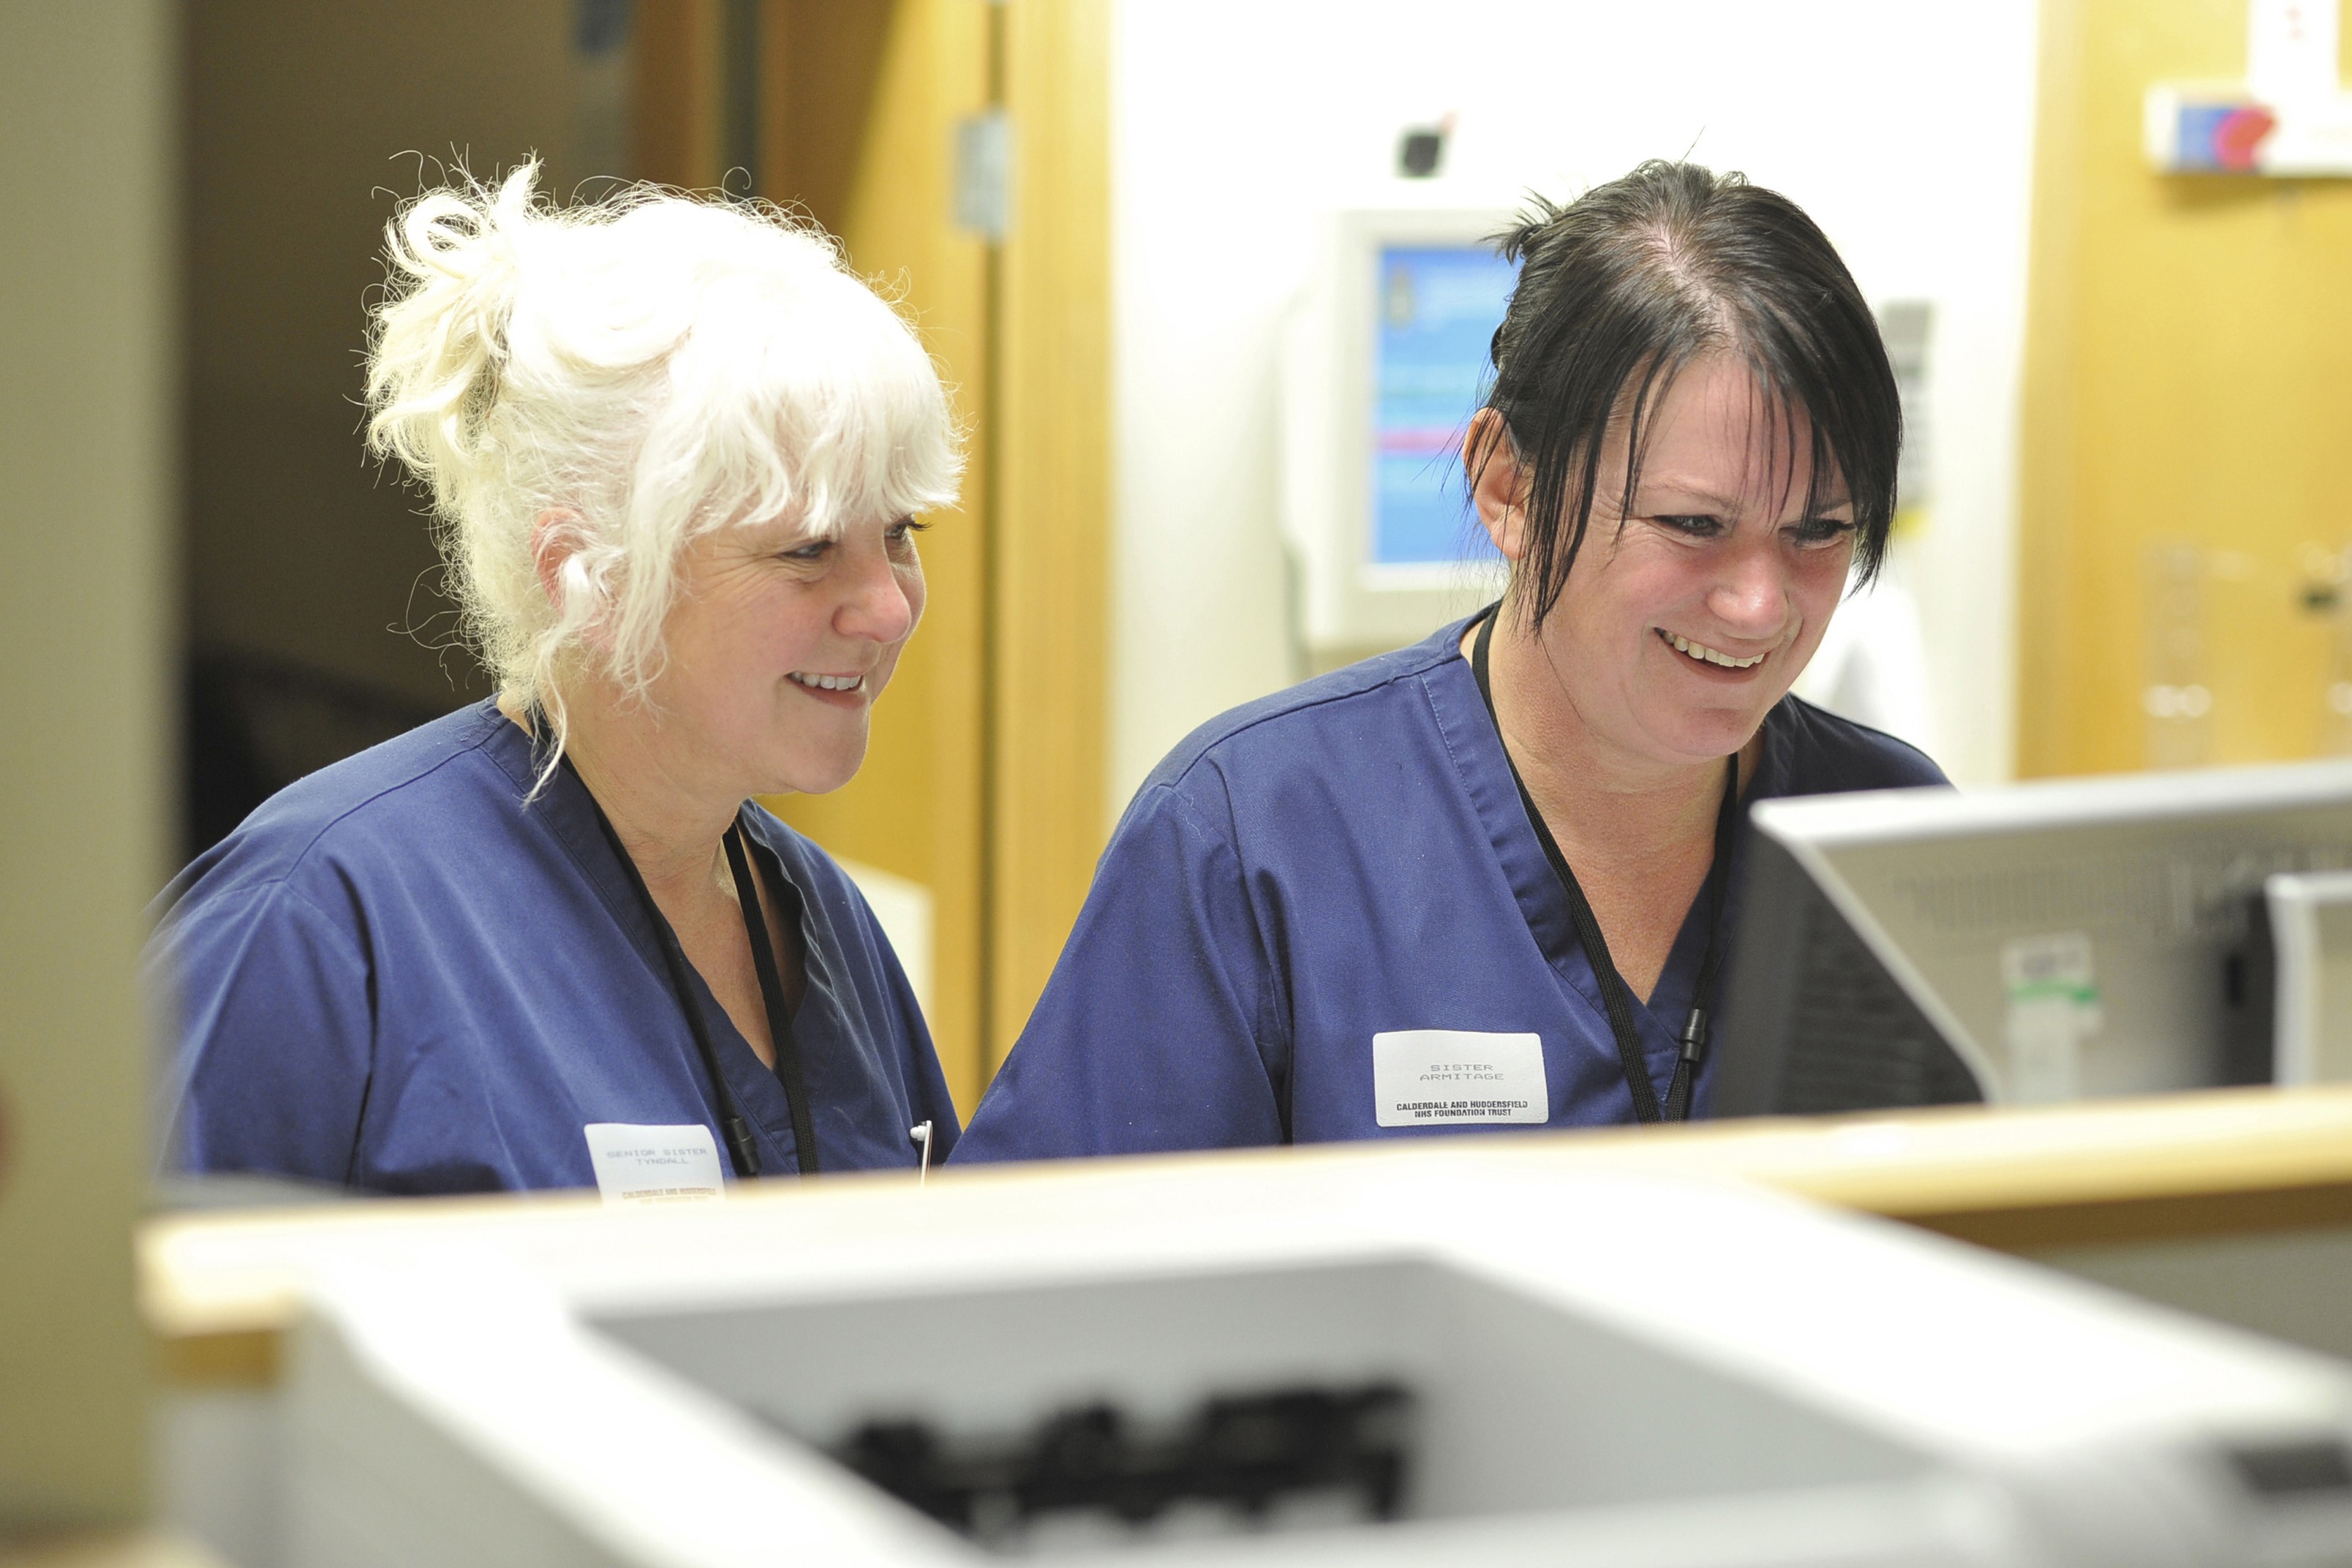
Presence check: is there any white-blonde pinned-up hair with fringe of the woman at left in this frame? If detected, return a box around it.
[367,162,962,757]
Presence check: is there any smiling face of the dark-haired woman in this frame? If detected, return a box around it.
[1482,358,1853,764]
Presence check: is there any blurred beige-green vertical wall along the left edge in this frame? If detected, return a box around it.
[0,0,172,1539]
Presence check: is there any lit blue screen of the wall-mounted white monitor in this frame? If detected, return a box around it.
[1371,244,1517,567]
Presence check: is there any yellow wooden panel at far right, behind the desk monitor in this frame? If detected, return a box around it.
[2018,0,2352,776]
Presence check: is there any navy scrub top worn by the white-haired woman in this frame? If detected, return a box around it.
[148,703,957,1192]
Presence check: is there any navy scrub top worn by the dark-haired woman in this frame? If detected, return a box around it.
[957,621,1945,1161]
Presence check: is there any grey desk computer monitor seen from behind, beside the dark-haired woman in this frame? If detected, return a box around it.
[1708,761,2352,1117]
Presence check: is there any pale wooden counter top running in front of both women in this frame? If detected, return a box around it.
[139,1088,2352,1384]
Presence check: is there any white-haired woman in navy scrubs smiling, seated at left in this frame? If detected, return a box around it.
[151,169,960,1196]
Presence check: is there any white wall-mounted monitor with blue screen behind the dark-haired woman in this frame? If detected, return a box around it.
[1282,205,1517,668]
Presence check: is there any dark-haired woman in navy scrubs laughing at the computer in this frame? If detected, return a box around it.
[957,165,1942,1161]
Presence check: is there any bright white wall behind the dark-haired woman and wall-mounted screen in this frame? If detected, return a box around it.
[1110,0,2035,811]
